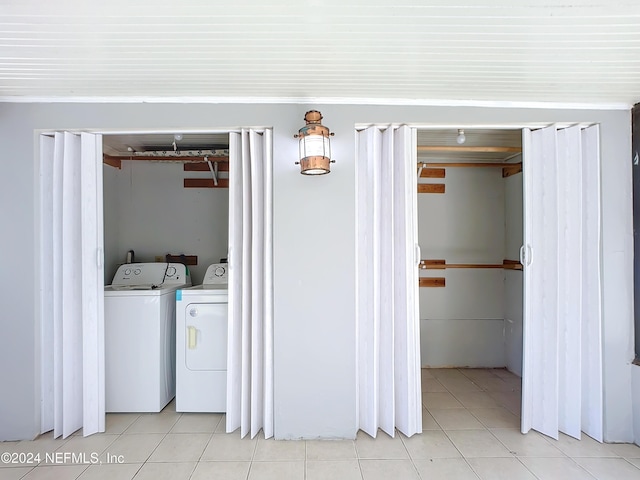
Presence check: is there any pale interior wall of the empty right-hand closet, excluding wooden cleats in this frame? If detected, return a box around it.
[418,139,523,375]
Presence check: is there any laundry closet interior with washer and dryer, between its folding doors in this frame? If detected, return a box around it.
[103,133,229,413]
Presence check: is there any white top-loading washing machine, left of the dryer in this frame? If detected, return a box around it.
[104,263,191,412]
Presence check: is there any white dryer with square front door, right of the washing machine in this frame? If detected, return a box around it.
[176,263,228,412]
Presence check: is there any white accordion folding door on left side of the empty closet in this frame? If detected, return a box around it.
[356,126,422,437]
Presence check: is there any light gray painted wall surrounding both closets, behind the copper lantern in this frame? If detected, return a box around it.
[0,104,633,441]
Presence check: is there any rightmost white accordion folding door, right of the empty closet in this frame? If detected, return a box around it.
[522,126,602,440]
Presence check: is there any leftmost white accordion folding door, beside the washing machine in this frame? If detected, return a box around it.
[40,132,105,437]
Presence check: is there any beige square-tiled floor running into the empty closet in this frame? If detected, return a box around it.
[0,369,640,480]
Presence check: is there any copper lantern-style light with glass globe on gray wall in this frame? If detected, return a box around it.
[294,110,335,175]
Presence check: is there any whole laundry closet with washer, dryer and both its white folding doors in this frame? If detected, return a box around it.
[39,128,273,438]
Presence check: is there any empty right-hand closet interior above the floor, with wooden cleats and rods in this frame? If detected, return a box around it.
[417,128,523,376]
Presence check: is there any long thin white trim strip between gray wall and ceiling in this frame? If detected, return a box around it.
[0,95,633,110]
